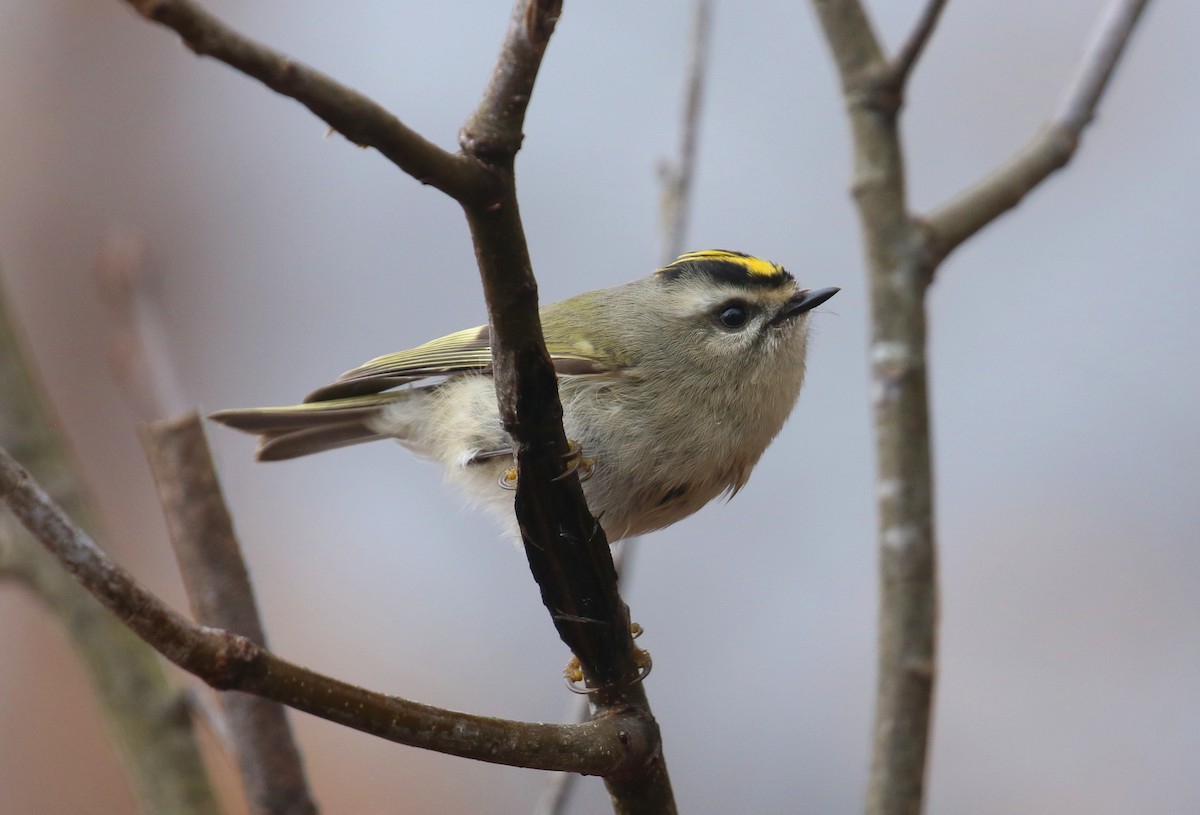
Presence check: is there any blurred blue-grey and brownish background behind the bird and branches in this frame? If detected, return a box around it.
[0,0,1200,815]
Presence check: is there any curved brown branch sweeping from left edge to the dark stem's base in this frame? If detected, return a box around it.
[0,449,658,775]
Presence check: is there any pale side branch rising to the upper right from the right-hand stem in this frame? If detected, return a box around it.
[924,0,1150,259]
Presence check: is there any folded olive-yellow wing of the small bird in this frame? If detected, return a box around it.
[305,325,613,402]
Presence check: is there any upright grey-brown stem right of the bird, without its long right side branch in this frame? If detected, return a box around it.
[814,0,938,815]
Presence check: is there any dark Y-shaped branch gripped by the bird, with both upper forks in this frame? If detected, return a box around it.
[118,0,674,813]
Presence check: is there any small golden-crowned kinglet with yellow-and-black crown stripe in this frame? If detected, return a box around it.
[212,251,838,540]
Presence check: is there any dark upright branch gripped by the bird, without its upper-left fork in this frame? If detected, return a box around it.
[460,0,674,814]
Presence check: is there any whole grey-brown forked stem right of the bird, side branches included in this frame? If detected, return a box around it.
[814,0,1146,815]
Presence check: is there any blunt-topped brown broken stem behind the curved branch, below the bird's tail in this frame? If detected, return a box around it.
[140,413,317,815]
